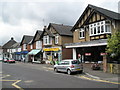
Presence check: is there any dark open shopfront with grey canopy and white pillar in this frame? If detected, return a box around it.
[66,40,107,63]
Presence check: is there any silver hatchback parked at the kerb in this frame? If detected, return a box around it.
[54,59,83,75]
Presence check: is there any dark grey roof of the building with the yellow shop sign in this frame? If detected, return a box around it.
[48,23,73,36]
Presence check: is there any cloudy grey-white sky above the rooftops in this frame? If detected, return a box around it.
[0,0,120,45]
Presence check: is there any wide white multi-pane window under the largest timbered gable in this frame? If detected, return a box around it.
[89,21,111,36]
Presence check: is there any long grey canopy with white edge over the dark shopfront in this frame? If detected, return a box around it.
[65,39,107,48]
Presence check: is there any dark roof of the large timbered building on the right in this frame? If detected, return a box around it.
[71,4,120,31]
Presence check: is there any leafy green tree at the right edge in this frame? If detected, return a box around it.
[106,29,120,60]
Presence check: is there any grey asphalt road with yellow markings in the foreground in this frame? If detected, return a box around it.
[2,63,118,89]
